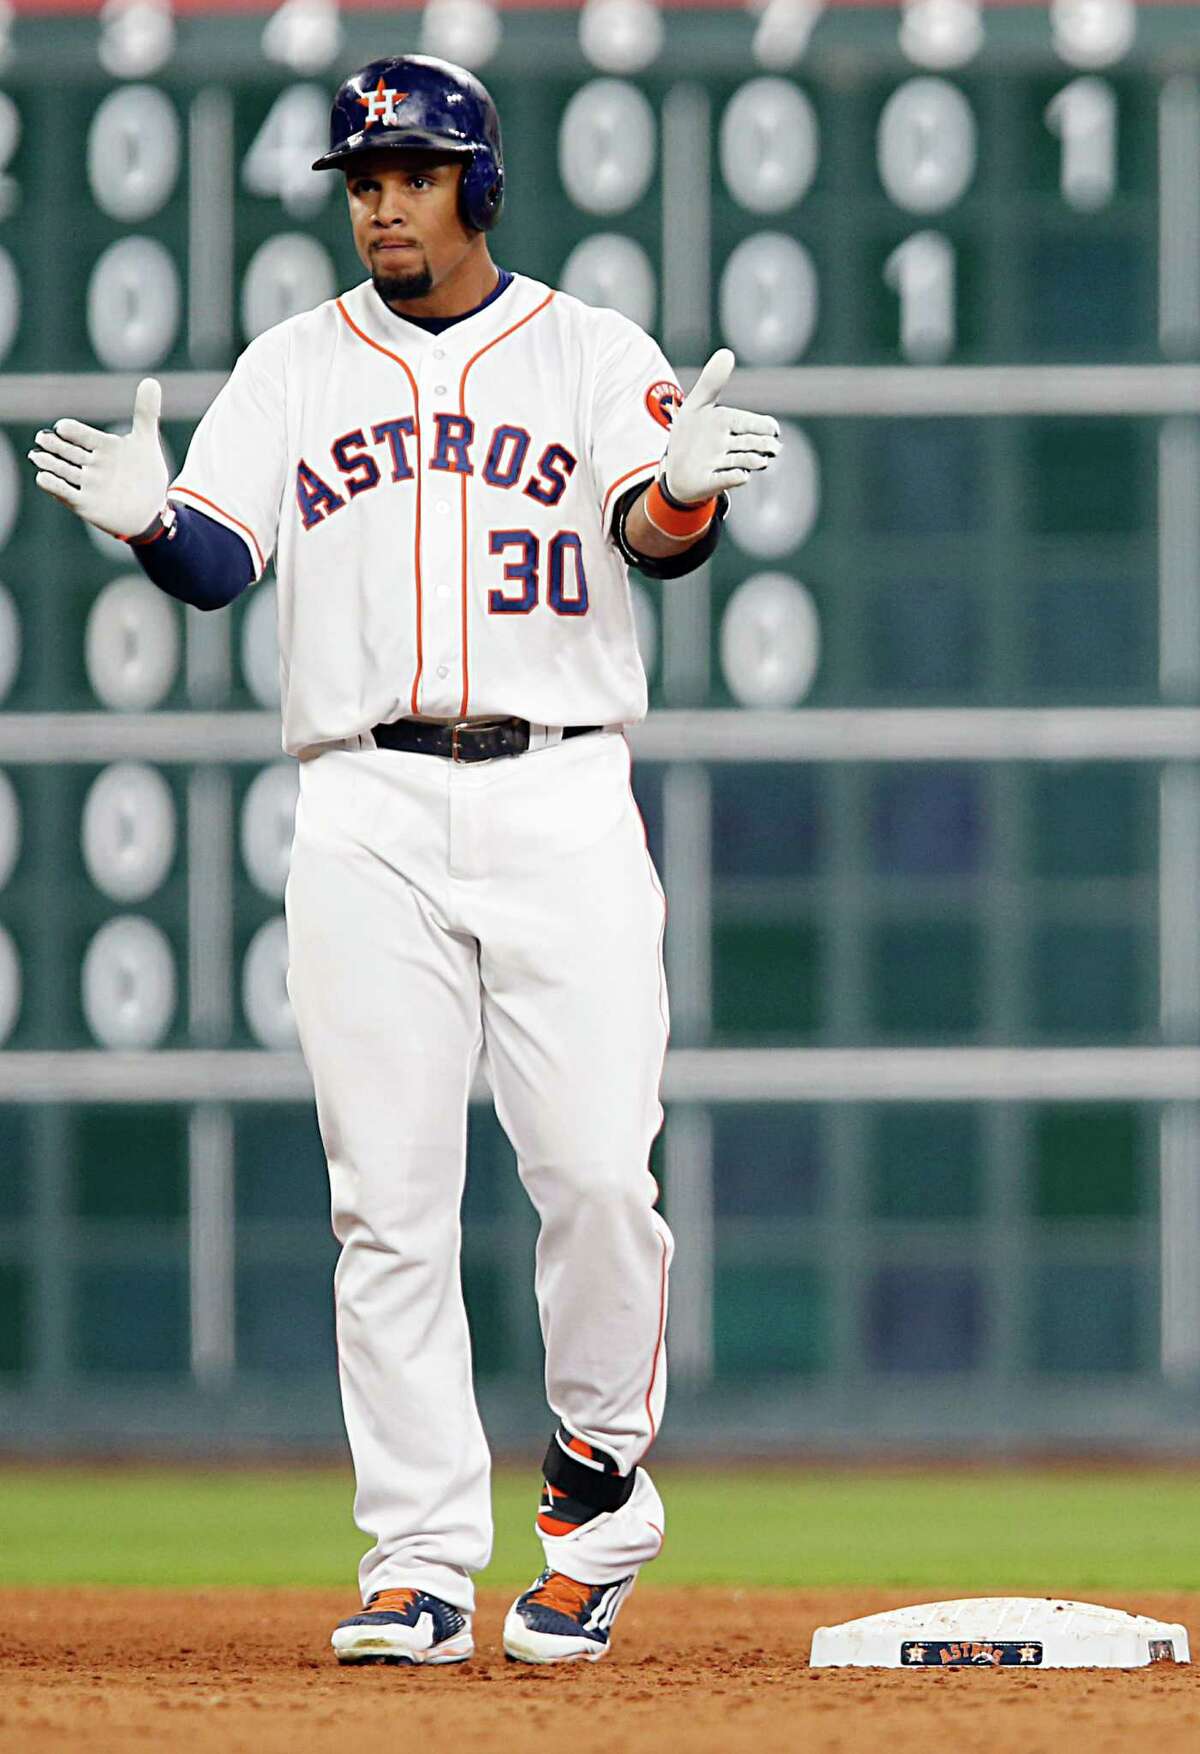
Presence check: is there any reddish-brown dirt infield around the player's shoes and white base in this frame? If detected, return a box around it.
[0,1589,1200,1754]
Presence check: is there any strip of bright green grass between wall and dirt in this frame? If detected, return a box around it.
[0,1466,1200,1596]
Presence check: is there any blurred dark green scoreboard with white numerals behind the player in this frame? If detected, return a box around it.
[0,0,1200,1430]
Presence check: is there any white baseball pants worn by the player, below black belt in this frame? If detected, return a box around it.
[286,731,672,1610]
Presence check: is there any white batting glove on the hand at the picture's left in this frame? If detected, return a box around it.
[28,377,167,542]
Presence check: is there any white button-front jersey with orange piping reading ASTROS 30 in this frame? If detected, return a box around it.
[170,275,679,754]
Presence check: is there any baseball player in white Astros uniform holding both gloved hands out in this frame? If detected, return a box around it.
[30,56,779,1663]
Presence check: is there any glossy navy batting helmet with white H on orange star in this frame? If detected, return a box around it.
[312,54,504,232]
